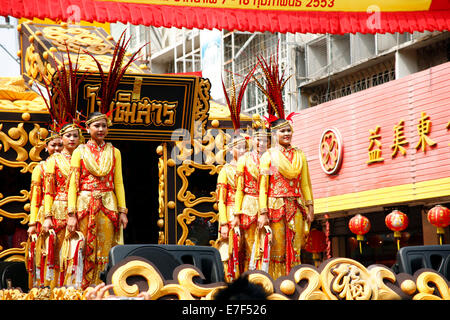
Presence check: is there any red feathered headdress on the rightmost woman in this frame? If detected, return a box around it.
[254,51,294,129]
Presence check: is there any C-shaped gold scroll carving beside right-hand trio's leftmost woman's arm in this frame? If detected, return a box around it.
[177,160,218,208]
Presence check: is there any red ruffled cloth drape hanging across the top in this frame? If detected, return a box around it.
[0,0,450,34]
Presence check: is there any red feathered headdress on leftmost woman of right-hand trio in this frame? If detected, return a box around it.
[222,66,256,147]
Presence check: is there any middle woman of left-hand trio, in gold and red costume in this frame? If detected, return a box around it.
[43,123,82,288]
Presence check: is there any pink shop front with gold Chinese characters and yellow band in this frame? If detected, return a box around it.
[294,62,450,265]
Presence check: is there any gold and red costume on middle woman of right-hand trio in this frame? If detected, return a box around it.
[234,151,259,272]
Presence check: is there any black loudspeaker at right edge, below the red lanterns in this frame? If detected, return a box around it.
[395,244,450,280]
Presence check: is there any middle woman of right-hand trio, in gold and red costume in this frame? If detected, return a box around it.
[234,117,270,271]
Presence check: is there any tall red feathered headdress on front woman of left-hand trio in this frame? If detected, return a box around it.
[86,30,146,126]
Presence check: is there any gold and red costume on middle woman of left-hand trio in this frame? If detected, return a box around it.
[44,151,71,288]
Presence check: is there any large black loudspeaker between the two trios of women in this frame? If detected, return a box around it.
[101,244,225,284]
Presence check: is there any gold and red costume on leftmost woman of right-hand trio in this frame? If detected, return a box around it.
[217,163,236,281]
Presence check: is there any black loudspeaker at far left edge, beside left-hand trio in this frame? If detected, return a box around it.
[0,261,29,292]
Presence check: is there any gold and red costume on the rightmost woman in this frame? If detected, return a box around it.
[259,146,313,279]
